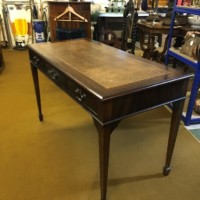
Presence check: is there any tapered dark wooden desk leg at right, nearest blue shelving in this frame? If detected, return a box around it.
[163,100,185,176]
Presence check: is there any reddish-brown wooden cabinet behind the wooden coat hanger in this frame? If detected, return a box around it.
[48,1,91,42]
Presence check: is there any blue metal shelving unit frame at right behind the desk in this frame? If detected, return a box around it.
[165,0,200,126]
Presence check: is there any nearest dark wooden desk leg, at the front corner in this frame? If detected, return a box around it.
[93,118,119,200]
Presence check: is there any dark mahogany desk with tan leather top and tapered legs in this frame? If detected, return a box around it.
[28,39,192,200]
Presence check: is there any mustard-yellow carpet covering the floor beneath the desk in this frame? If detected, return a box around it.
[0,49,200,200]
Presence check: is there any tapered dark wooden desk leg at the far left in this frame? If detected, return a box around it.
[31,64,43,121]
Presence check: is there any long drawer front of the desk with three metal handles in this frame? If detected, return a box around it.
[29,51,98,116]
